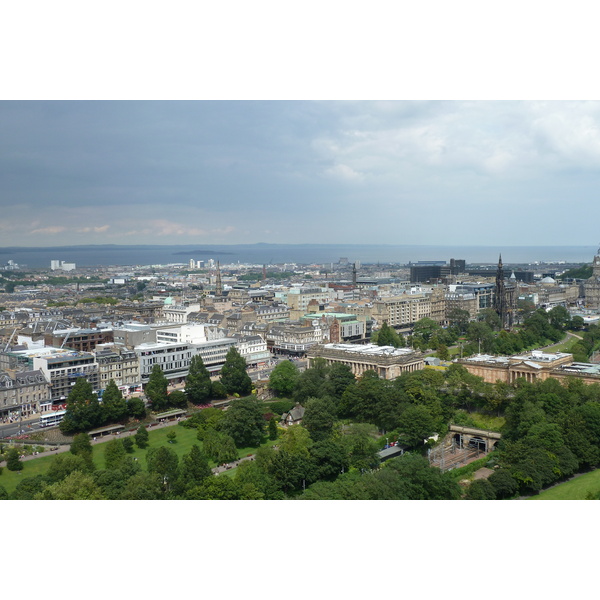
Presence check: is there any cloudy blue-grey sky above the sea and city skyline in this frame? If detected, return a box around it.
[0,101,600,246]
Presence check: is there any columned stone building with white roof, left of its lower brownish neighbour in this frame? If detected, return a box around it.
[308,344,425,379]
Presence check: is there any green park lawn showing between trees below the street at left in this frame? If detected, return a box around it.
[0,425,277,494]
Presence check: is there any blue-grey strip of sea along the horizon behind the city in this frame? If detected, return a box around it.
[0,244,598,268]
